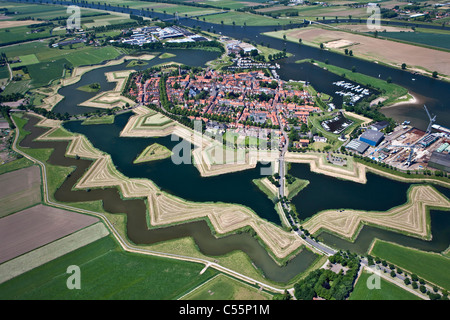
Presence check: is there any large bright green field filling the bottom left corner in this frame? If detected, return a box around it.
[0,236,217,300]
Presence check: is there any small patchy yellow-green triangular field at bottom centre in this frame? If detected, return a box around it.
[182,274,272,300]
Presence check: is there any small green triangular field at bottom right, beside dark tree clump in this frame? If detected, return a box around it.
[349,271,421,300]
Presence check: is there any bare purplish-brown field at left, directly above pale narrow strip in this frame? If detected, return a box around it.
[0,204,99,263]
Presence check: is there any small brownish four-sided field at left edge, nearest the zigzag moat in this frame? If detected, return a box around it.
[0,166,41,217]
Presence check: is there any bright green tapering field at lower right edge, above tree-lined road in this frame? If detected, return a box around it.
[370,240,450,290]
